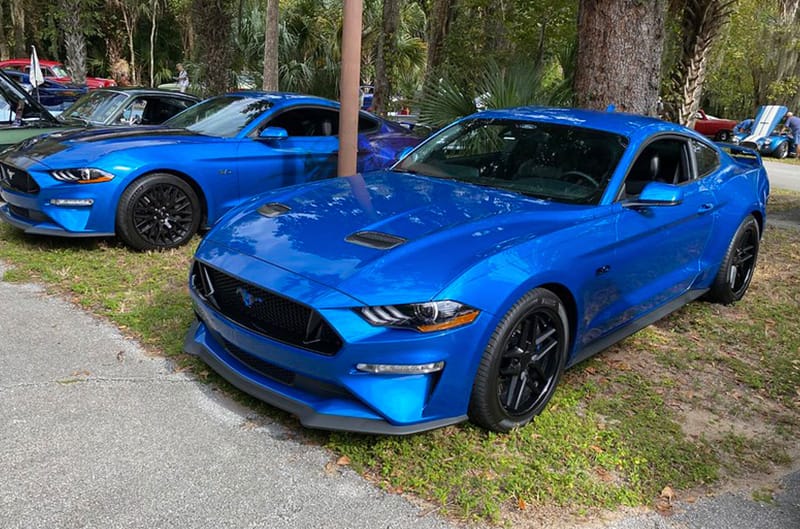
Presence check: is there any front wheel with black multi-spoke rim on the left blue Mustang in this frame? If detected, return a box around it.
[117,173,201,250]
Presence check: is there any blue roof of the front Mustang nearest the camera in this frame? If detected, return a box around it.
[465,106,694,137]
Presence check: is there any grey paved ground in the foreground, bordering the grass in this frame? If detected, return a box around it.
[0,264,800,529]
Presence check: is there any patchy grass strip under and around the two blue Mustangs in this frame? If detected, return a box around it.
[0,192,800,524]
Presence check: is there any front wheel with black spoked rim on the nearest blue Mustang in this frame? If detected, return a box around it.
[469,288,569,432]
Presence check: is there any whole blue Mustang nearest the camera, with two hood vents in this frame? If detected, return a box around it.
[184,108,769,434]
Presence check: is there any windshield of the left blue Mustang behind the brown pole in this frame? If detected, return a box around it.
[164,95,272,138]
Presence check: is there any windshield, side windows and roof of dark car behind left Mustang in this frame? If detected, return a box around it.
[59,86,200,126]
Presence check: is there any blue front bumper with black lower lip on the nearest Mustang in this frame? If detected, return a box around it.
[184,248,493,434]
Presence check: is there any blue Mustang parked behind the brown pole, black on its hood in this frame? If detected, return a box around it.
[0,92,419,250]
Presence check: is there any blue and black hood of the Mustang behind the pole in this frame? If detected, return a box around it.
[5,126,209,168]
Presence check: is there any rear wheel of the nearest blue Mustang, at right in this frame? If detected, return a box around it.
[706,215,760,305]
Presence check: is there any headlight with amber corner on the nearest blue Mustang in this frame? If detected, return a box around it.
[356,301,480,332]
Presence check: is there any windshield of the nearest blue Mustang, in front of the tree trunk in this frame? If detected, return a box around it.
[393,119,627,204]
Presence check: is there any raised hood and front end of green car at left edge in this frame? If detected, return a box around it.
[0,70,80,150]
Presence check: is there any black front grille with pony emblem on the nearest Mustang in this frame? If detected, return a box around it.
[192,262,342,355]
